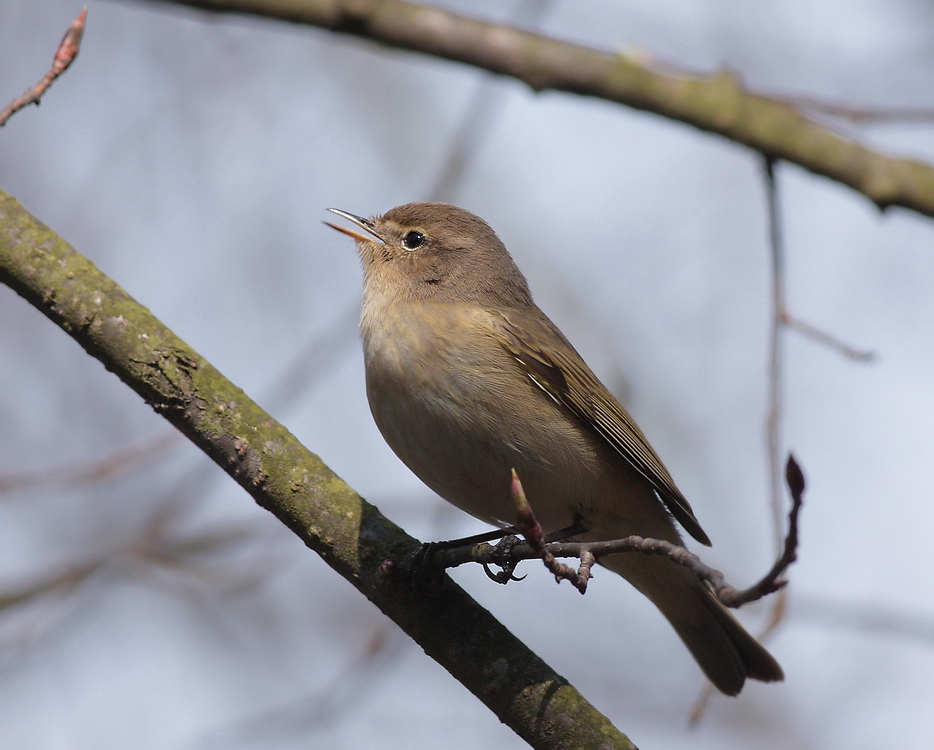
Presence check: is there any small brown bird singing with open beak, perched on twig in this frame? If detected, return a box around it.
[326,203,783,695]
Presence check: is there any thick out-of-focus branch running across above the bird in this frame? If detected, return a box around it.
[137,0,934,217]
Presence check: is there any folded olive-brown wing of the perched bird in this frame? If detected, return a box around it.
[495,310,710,545]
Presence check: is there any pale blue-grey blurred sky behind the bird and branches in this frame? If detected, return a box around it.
[0,0,934,750]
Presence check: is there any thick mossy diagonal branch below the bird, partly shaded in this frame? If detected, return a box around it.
[0,192,633,750]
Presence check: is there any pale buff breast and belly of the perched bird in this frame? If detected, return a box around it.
[362,305,658,529]
